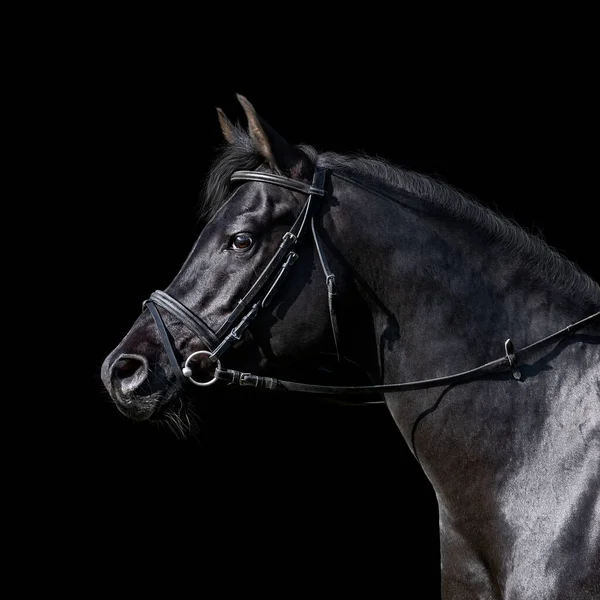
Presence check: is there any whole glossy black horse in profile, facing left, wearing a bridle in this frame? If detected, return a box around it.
[102,97,600,600]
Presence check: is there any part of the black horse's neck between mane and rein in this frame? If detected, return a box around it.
[329,171,600,383]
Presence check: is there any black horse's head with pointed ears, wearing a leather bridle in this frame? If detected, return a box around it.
[102,96,352,420]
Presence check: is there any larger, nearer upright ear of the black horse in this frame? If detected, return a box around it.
[236,94,308,177]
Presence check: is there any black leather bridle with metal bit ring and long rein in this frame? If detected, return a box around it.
[144,167,600,404]
